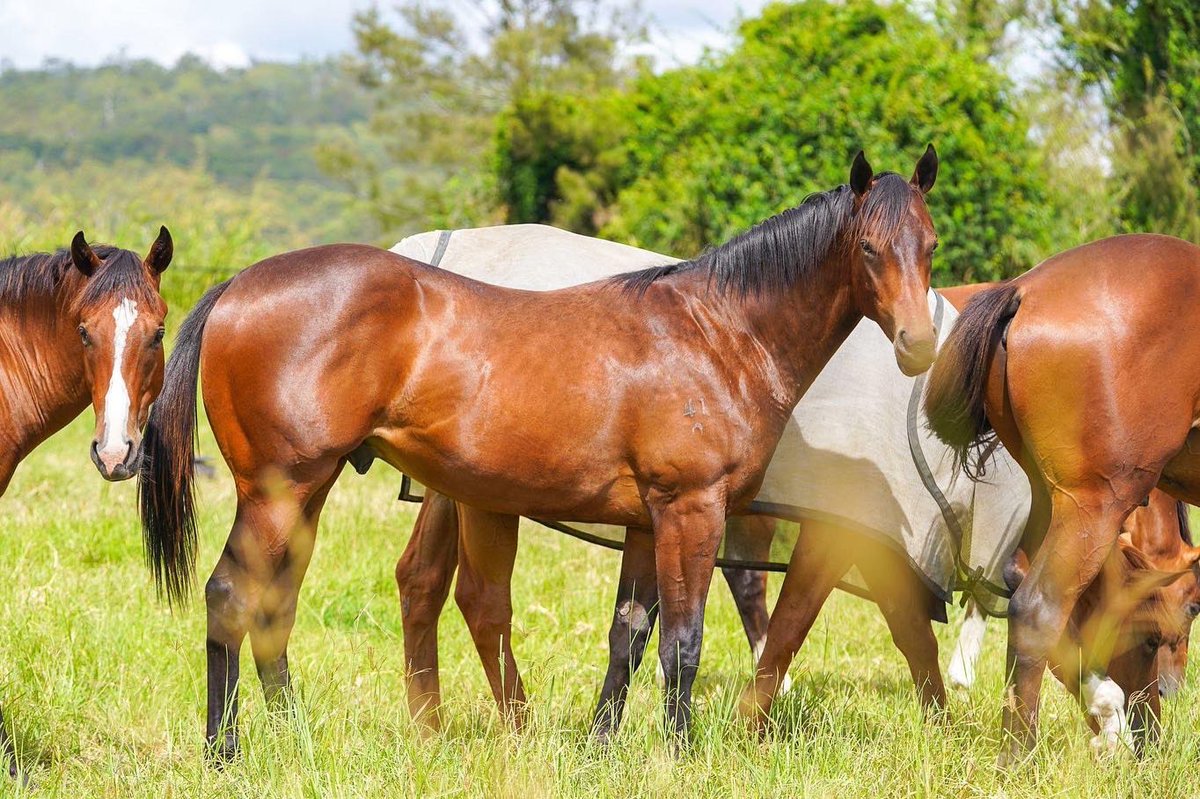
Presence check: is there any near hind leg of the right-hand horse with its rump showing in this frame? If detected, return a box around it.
[1000,485,1139,768]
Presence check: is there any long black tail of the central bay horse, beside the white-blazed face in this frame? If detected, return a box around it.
[138,281,229,605]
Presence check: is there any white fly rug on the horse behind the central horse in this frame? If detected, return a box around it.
[392,224,1030,614]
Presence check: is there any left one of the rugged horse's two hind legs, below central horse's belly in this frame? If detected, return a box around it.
[396,491,458,733]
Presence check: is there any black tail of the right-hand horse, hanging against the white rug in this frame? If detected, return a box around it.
[925,283,1021,479]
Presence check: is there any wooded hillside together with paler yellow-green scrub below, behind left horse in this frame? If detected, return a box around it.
[0,56,391,263]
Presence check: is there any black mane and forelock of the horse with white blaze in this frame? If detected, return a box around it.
[0,245,157,307]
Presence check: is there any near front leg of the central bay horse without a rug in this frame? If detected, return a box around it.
[649,491,725,751]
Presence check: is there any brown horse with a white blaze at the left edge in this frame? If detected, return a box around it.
[0,228,173,775]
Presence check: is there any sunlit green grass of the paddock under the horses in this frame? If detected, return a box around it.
[0,410,1200,799]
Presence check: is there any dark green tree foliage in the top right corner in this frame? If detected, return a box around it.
[1056,0,1200,239]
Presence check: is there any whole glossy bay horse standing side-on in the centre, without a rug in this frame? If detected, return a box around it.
[140,148,937,757]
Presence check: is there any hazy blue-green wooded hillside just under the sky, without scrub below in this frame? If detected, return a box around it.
[0,56,370,185]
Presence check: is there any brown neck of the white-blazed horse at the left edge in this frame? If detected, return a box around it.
[0,284,89,453]
